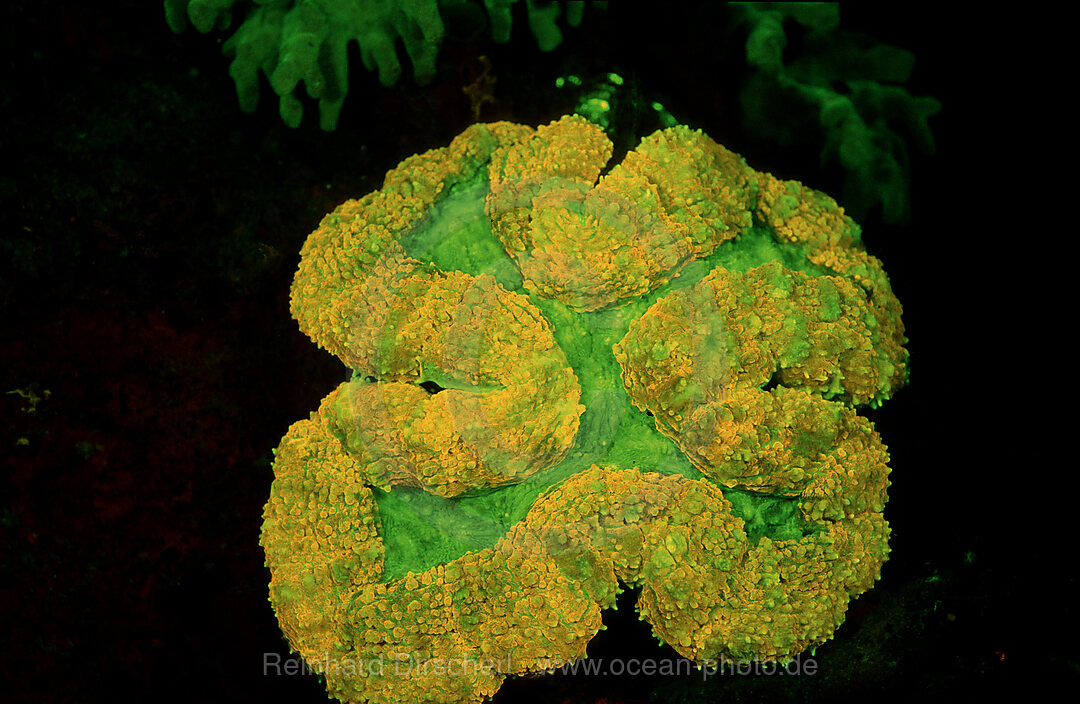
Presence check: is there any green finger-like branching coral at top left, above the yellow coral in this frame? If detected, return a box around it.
[165,0,584,130]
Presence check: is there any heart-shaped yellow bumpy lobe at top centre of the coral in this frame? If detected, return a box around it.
[487,116,756,311]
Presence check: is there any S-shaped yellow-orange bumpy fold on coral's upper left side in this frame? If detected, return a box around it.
[293,123,582,496]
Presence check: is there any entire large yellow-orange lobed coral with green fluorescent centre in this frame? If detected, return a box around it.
[261,117,906,703]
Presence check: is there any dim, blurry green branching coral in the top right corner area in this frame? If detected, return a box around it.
[731,2,941,222]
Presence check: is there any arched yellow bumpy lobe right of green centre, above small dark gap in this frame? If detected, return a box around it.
[615,261,906,412]
